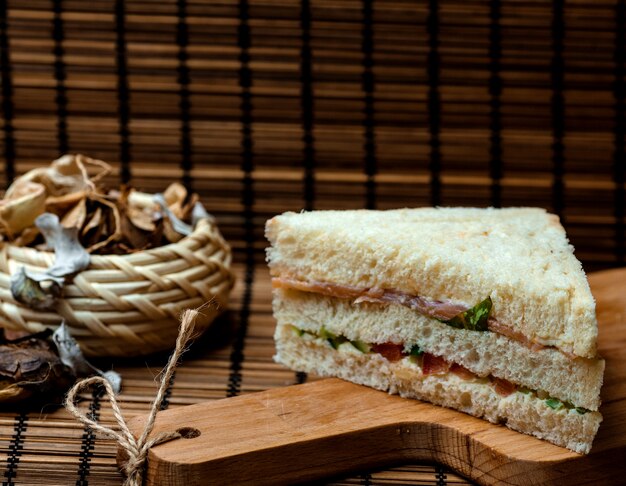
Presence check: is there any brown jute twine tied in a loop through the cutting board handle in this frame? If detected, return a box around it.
[65,310,198,486]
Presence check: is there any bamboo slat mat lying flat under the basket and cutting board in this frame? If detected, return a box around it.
[0,265,471,486]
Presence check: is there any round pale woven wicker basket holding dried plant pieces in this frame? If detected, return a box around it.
[0,220,234,356]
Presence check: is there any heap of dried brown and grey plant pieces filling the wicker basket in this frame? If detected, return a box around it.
[0,155,211,309]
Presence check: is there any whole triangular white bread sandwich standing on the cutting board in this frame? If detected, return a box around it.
[266,208,604,454]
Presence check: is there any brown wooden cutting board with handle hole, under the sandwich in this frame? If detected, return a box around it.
[119,269,626,486]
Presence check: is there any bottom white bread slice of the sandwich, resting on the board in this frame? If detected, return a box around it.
[274,325,602,454]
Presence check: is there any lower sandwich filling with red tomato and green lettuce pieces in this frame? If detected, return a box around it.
[288,325,589,415]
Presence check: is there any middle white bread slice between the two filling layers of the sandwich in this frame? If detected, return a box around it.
[273,289,604,410]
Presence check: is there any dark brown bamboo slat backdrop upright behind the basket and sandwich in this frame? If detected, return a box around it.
[0,0,626,484]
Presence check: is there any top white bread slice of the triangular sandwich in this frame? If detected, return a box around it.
[266,208,598,358]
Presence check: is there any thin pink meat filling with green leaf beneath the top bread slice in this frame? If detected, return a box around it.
[272,276,577,359]
